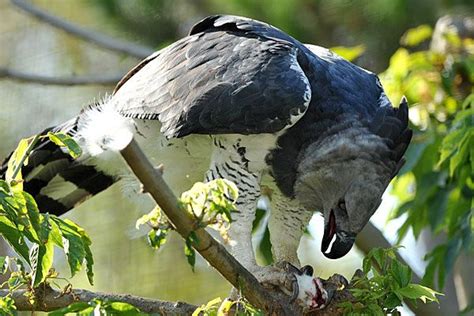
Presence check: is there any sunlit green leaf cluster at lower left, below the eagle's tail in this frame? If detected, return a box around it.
[0,134,94,313]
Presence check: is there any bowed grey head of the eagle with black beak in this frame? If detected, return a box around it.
[293,100,411,259]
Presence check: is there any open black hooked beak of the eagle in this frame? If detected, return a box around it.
[321,210,356,259]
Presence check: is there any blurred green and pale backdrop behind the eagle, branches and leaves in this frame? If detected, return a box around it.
[0,0,474,315]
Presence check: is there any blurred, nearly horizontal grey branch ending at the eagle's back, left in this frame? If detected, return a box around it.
[0,67,123,86]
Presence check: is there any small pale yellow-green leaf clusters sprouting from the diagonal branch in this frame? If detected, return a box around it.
[136,179,238,270]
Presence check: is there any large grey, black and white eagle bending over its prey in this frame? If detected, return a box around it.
[0,15,412,307]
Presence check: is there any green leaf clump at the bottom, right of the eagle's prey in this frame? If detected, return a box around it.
[341,248,441,315]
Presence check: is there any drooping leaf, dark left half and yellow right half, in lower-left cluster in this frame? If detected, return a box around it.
[30,241,54,287]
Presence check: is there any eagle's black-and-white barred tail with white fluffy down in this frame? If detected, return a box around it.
[0,101,131,216]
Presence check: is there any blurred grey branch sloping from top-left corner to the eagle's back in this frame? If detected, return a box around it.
[11,0,155,59]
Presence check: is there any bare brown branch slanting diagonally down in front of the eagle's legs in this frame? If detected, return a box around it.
[122,140,294,314]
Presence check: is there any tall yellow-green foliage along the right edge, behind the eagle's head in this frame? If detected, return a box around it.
[381,26,474,288]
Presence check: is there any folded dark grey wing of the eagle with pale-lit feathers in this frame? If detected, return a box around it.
[114,17,310,137]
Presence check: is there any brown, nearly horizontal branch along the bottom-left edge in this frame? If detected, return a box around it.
[0,286,197,315]
